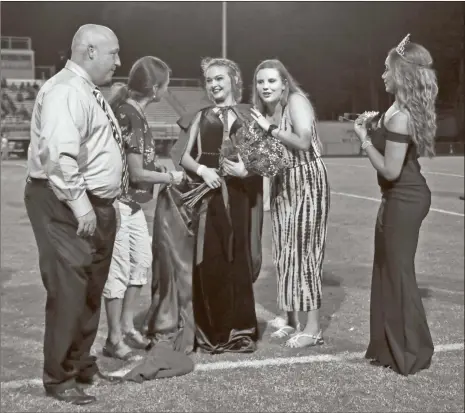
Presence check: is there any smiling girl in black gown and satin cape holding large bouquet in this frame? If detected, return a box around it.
[148,59,263,354]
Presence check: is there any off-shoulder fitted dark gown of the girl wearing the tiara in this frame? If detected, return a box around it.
[366,112,434,375]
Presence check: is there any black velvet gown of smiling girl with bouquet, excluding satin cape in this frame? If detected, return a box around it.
[193,109,258,353]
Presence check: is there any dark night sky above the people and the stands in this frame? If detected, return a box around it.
[1,2,464,117]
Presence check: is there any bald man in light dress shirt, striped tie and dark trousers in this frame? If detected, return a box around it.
[24,25,126,405]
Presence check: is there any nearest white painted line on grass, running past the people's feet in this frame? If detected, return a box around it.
[1,343,464,390]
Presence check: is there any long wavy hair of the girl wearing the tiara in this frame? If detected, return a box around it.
[388,43,438,158]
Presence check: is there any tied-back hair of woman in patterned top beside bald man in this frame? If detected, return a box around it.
[108,56,171,110]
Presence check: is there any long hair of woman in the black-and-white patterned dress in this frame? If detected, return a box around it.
[252,59,323,152]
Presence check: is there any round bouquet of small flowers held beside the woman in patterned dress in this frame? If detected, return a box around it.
[236,120,288,177]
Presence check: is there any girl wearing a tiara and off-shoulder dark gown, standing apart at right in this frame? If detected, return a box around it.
[355,36,438,375]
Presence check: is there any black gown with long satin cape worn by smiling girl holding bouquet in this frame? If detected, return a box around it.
[144,105,263,353]
